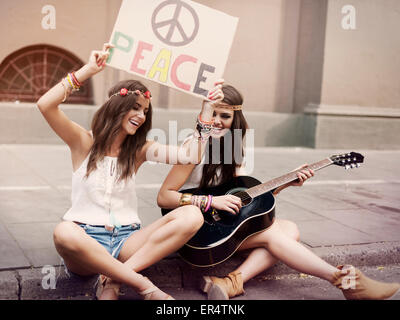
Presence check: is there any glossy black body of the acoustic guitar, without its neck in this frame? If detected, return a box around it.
[162,176,275,267]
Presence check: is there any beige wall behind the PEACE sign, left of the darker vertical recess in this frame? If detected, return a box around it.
[0,0,300,113]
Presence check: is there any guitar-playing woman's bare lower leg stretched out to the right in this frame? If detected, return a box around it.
[242,219,339,281]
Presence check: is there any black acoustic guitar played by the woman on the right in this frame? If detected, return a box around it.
[161,152,364,267]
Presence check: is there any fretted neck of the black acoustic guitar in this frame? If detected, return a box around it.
[246,158,333,198]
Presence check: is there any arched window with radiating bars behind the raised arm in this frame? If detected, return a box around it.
[0,45,93,104]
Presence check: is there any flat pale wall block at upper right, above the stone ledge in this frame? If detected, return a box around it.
[321,0,400,109]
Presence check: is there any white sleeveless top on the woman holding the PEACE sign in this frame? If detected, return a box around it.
[63,155,141,226]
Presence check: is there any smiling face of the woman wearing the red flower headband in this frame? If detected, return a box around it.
[122,95,150,135]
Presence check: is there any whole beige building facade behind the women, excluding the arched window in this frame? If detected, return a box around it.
[0,0,400,148]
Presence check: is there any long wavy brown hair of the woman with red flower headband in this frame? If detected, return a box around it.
[86,80,152,180]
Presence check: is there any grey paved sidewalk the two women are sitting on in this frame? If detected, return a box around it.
[0,145,400,299]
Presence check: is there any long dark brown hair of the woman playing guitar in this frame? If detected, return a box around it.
[199,85,249,188]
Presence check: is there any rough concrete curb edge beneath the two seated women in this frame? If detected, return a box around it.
[0,242,400,300]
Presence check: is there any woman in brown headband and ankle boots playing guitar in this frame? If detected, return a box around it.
[157,86,400,300]
